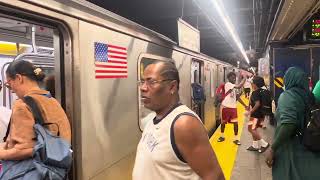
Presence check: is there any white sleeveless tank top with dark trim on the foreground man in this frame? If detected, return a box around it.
[132,104,201,180]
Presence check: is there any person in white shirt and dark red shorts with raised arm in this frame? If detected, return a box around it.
[218,72,246,145]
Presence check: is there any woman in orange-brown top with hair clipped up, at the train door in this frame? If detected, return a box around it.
[0,60,71,160]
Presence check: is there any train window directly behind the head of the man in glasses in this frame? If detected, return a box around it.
[138,54,170,131]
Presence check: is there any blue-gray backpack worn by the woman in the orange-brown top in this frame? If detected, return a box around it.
[0,95,72,180]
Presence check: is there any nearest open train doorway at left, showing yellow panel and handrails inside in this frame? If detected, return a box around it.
[0,11,72,179]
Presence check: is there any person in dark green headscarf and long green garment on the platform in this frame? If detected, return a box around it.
[266,67,320,180]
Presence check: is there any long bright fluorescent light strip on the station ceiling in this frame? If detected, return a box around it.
[212,0,250,64]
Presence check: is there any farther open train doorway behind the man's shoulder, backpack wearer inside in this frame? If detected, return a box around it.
[191,59,204,121]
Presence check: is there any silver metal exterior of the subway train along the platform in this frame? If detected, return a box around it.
[0,0,238,180]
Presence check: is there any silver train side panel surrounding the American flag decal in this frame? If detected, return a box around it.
[79,21,143,179]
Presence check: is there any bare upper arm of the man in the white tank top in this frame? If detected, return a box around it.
[174,115,225,180]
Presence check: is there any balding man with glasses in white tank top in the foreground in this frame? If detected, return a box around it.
[132,61,224,180]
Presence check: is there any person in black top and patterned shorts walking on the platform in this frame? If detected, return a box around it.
[246,76,269,153]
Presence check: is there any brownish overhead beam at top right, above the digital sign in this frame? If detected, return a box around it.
[269,0,320,41]
